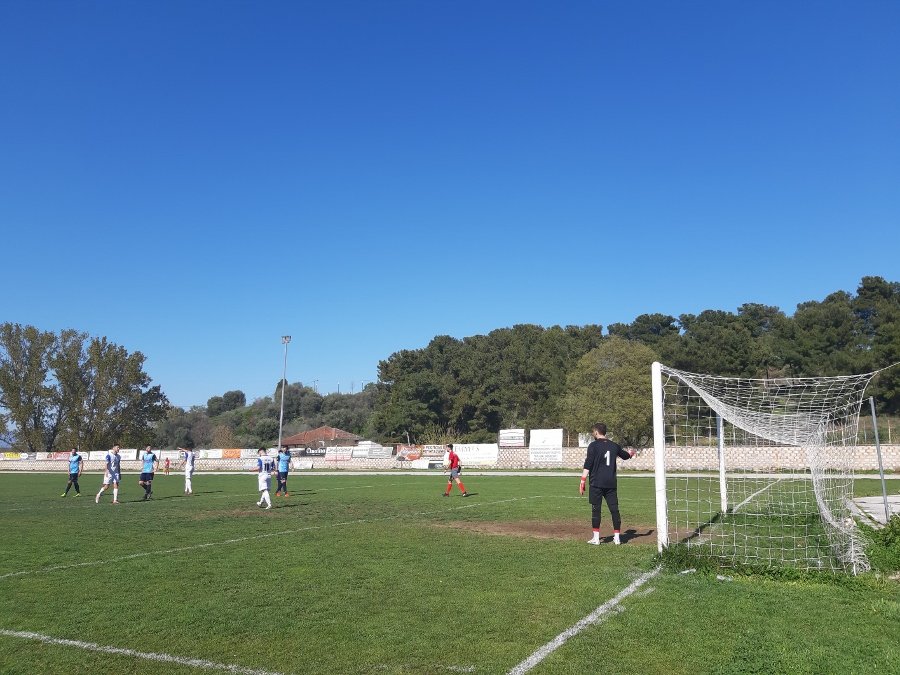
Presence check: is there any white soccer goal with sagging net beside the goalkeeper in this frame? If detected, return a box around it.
[652,363,875,574]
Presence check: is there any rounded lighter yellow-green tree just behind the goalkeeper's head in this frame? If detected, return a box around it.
[560,337,658,448]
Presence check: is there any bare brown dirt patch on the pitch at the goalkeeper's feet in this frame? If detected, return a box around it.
[435,520,656,545]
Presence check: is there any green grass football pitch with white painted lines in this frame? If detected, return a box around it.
[0,474,900,674]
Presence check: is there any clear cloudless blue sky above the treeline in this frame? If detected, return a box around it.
[0,0,900,406]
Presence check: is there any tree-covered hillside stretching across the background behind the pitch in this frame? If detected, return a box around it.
[0,277,900,452]
